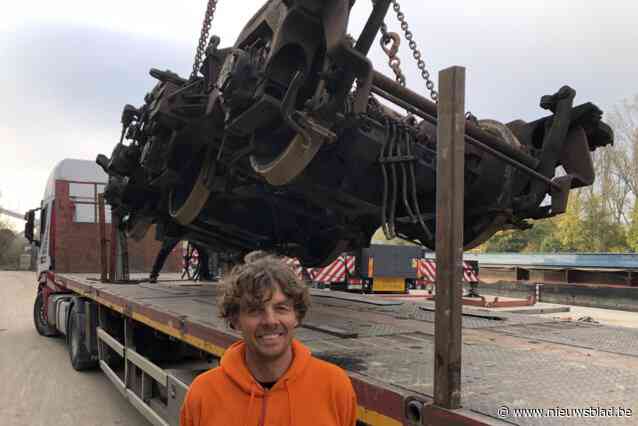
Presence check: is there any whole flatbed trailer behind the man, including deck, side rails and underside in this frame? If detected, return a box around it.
[45,272,638,425]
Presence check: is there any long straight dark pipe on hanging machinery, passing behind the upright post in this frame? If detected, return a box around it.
[372,71,539,169]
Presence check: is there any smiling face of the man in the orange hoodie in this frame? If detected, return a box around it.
[233,284,299,363]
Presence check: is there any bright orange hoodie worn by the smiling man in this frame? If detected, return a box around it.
[180,340,357,426]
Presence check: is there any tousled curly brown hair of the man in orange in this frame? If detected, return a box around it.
[218,254,310,328]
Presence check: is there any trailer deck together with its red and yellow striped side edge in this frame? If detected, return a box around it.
[50,274,638,425]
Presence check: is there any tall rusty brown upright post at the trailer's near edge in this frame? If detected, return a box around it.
[434,67,465,409]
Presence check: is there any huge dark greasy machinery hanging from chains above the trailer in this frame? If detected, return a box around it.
[91,0,613,266]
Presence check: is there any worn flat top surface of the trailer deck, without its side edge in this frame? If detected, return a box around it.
[62,275,638,425]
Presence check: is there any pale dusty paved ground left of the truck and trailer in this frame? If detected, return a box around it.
[0,271,149,426]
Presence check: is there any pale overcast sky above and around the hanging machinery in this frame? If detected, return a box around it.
[0,0,638,227]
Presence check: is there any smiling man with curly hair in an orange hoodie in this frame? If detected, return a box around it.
[180,253,357,426]
